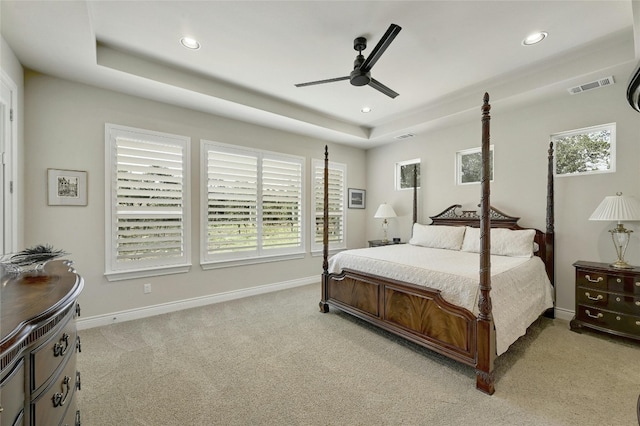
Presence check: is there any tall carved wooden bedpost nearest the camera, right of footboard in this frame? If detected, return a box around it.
[476,93,497,395]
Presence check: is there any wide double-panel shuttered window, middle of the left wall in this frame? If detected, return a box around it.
[201,141,304,268]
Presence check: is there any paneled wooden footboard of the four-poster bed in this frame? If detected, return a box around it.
[325,270,477,366]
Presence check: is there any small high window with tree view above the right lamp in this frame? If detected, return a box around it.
[551,123,616,176]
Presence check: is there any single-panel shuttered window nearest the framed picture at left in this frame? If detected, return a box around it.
[105,124,190,280]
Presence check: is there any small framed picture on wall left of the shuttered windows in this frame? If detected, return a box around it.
[47,169,87,206]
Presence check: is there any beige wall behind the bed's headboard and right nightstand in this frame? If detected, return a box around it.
[367,79,640,313]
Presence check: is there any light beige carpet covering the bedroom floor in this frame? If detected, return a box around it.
[78,285,640,426]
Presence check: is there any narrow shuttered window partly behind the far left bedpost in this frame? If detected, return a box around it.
[311,159,347,252]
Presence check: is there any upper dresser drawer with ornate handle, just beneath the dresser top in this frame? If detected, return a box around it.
[29,311,77,393]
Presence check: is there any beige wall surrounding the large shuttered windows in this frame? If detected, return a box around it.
[24,72,365,317]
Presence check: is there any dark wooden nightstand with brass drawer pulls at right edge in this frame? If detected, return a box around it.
[570,261,640,340]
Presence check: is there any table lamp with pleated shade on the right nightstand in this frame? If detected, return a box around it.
[589,192,640,268]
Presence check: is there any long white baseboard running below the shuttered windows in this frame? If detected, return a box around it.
[77,276,320,330]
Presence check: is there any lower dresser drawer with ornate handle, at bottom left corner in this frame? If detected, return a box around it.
[31,351,78,425]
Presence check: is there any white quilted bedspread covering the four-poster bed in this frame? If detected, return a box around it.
[329,244,553,355]
